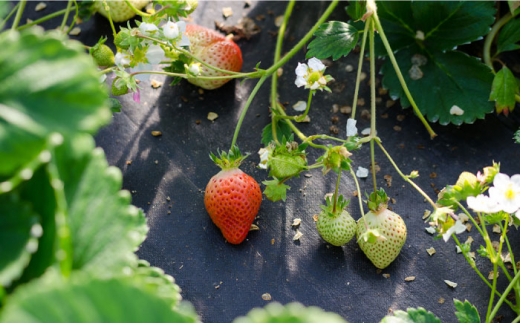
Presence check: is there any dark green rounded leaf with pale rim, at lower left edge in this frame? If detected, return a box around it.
[0,194,42,287]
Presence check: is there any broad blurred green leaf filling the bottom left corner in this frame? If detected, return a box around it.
[0,274,198,323]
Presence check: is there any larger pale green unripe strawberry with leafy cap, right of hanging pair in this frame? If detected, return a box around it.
[357,189,407,269]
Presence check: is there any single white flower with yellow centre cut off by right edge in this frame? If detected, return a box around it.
[489,173,520,213]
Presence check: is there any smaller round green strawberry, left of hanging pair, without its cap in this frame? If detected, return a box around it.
[316,210,356,247]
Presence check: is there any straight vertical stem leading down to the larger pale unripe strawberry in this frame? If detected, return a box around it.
[367,18,377,192]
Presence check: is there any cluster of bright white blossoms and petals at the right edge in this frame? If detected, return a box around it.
[467,173,520,218]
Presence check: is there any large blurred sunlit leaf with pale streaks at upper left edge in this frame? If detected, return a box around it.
[0,28,111,176]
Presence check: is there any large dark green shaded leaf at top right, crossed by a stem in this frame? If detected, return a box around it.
[376,1,496,125]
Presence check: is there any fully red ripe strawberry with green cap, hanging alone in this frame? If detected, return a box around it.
[204,147,262,244]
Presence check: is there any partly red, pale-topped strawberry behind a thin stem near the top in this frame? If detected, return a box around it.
[186,25,242,90]
